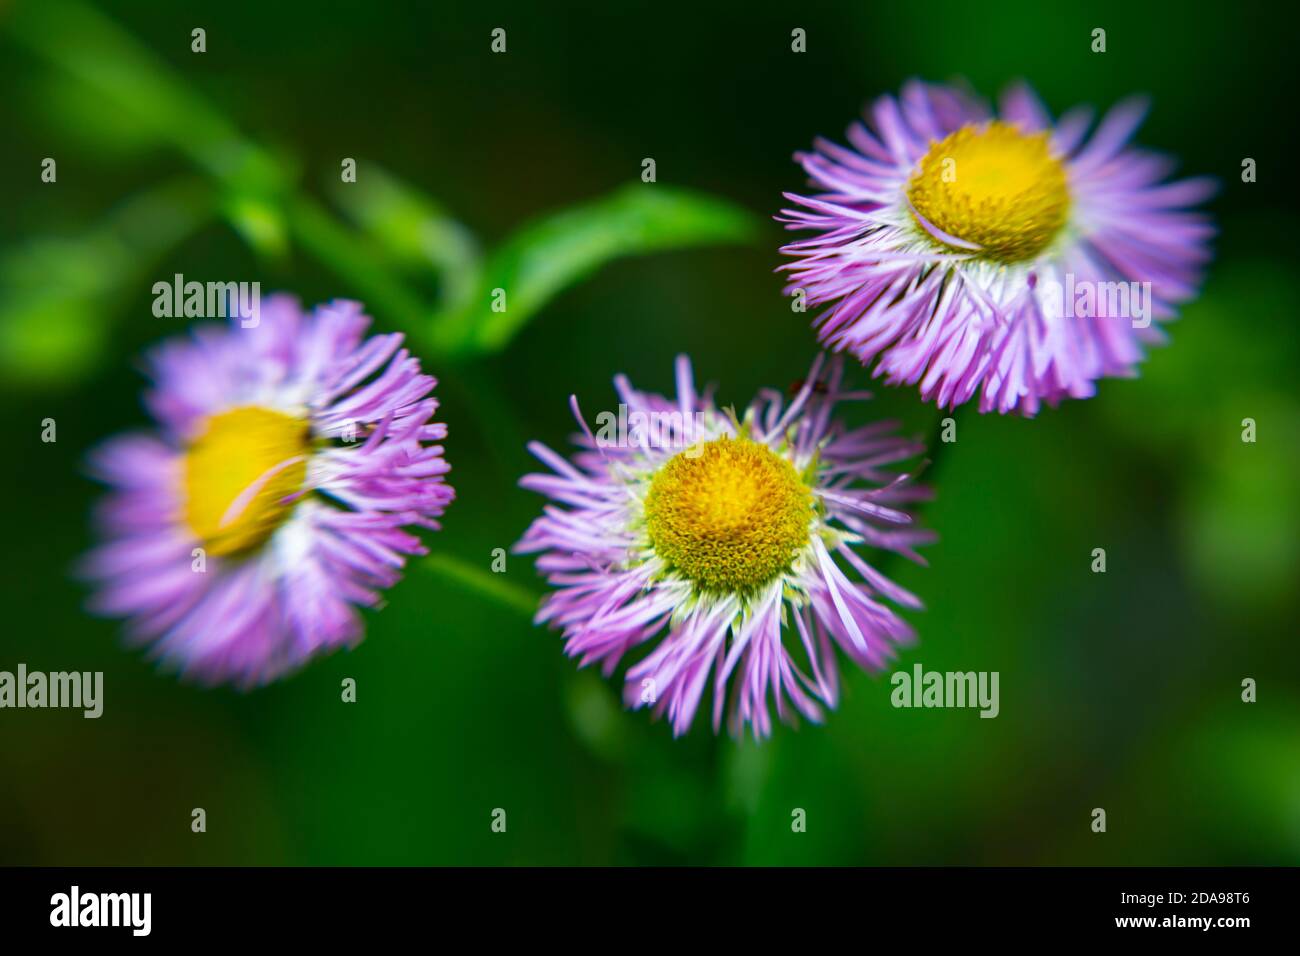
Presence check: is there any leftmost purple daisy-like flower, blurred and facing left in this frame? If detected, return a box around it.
[85,297,452,687]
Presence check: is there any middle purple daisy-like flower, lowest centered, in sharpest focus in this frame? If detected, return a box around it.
[516,356,933,737]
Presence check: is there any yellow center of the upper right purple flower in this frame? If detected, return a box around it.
[907,121,1070,263]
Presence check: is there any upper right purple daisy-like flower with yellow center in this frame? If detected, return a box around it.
[777,82,1214,415]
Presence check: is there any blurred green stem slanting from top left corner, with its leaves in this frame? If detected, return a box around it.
[8,0,757,369]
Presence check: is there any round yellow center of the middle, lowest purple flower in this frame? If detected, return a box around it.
[645,437,814,593]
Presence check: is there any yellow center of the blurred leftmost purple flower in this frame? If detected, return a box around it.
[185,407,311,555]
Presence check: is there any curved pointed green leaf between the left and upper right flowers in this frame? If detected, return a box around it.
[432,183,758,356]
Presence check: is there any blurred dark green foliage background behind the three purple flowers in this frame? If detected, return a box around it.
[0,0,1300,864]
